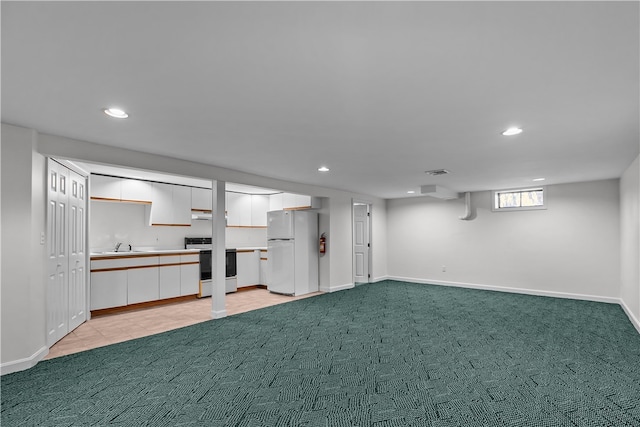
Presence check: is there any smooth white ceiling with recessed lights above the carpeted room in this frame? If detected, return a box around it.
[1,1,640,198]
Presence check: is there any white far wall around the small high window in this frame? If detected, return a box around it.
[387,180,620,301]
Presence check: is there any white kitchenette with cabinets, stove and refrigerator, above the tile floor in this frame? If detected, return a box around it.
[79,165,319,316]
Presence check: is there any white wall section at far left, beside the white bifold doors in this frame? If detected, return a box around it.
[0,124,48,373]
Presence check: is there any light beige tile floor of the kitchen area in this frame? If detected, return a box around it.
[45,289,321,359]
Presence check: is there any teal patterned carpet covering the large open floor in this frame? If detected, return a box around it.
[1,281,640,427]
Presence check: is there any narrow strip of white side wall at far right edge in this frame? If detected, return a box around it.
[620,157,640,332]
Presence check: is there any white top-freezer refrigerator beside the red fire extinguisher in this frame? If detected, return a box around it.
[267,210,318,295]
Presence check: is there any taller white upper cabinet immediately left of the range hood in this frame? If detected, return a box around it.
[149,182,191,226]
